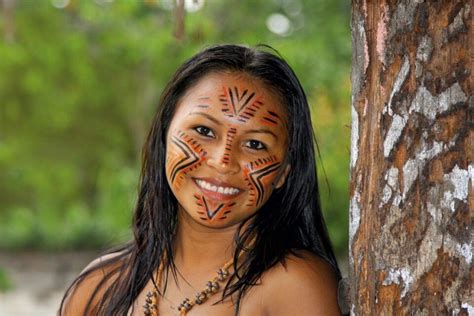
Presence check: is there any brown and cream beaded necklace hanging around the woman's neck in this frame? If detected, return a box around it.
[143,259,234,316]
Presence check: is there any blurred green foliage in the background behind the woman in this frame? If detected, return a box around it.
[0,0,350,253]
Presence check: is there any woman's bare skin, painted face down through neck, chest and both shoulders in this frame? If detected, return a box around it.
[60,73,340,316]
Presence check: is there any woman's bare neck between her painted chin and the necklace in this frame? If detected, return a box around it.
[174,209,238,272]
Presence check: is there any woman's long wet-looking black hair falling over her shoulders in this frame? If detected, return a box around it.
[61,45,340,315]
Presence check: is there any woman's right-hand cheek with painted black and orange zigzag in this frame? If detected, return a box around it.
[244,156,281,207]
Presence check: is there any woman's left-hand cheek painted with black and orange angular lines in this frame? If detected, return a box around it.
[166,131,206,190]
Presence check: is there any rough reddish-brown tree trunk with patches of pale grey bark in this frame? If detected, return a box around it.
[350,0,474,315]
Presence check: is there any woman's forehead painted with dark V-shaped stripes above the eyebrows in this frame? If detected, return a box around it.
[175,73,286,128]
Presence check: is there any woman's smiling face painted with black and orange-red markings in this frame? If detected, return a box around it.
[166,73,289,227]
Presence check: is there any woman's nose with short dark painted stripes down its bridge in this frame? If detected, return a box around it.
[207,133,240,174]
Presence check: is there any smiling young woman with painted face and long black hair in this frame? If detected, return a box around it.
[60,45,340,315]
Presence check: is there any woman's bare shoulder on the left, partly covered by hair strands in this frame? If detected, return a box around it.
[60,252,127,316]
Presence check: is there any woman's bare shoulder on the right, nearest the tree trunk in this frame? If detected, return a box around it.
[262,251,340,315]
